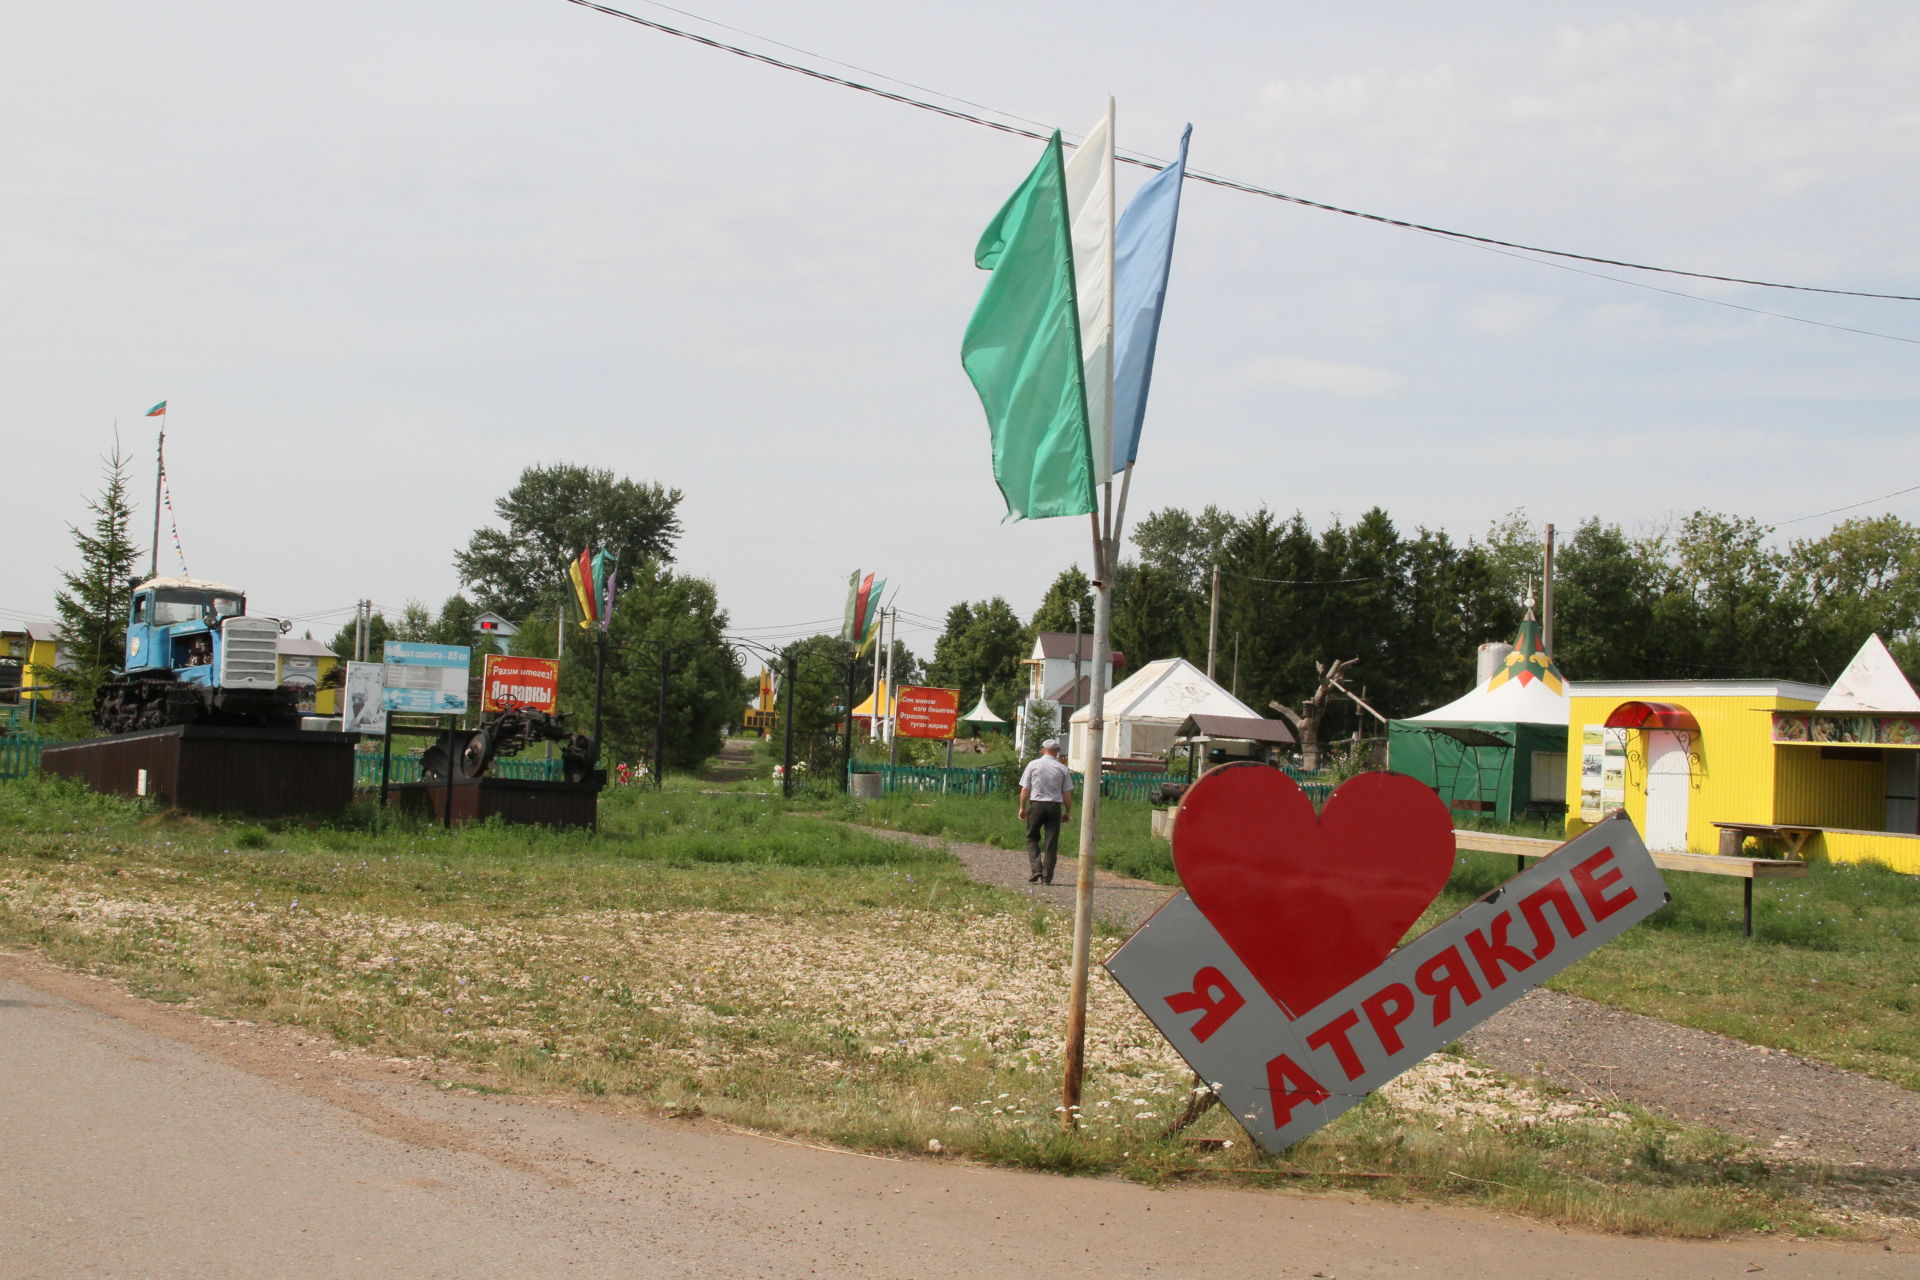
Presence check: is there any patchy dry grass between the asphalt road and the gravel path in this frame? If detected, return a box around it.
[0,779,1889,1236]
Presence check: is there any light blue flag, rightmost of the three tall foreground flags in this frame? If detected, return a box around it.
[1114,125,1194,474]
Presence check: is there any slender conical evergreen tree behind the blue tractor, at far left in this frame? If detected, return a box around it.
[36,441,140,712]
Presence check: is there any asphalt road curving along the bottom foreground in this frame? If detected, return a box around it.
[0,952,1920,1280]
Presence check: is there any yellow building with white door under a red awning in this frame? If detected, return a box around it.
[1567,677,1920,873]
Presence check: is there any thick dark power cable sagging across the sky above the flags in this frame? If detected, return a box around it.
[566,0,1920,303]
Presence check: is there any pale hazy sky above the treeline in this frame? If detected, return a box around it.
[0,0,1920,656]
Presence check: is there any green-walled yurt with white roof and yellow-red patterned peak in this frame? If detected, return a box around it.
[1386,610,1572,821]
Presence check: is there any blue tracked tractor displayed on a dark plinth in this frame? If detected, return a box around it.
[94,578,300,733]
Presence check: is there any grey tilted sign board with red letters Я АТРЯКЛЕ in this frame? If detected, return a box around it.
[1106,816,1667,1151]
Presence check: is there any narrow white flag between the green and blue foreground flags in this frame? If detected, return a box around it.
[1066,98,1114,482]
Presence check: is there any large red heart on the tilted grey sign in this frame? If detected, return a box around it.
[1173,764,1453,1017]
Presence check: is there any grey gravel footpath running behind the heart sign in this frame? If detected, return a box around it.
[866,827,1920,1182]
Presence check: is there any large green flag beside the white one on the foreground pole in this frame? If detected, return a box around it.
[960,132,1098,520]
